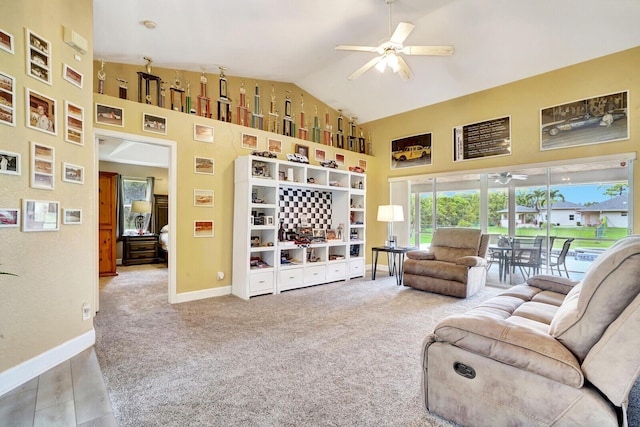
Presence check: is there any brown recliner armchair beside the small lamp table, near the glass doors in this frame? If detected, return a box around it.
[403,228,489,298]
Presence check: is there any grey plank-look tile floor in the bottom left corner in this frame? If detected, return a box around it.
[0,347,117,427]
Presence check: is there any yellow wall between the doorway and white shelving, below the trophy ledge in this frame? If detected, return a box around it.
[94,94,371,294]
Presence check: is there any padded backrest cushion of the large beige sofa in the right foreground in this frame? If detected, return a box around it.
[549,236,640,362]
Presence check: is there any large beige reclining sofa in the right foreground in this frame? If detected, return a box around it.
[422,236,640,426]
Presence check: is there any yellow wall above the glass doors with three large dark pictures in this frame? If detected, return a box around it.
[365,47,640,249]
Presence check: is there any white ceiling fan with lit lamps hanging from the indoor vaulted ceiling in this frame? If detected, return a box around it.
[336,0,453,80]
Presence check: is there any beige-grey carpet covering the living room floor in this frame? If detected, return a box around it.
[95,266,638,426]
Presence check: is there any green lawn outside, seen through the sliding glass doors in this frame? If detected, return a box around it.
[411,226,628,248]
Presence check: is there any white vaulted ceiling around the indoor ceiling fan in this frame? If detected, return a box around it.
[94,0,640,166]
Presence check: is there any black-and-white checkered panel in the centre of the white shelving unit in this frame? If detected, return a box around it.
[279,188,331,230]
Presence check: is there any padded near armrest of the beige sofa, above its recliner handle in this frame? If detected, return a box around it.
[430,313,584,388]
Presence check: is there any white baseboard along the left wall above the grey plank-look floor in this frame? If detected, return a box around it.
[0,329,96,396]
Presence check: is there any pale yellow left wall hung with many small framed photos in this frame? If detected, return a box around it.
[0,0,98,372]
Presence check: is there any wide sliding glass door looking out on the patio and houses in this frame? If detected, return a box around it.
[410,158,633,278]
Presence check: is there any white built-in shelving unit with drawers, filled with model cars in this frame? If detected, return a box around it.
[232,156,366,299]
